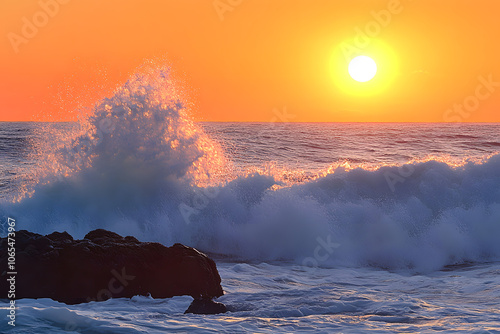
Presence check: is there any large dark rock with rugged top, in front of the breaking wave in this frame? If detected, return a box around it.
[0,230,223,304]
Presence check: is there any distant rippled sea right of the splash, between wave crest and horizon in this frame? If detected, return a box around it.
[202,123,500,173]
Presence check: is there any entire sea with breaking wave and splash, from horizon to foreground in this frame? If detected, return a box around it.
[0,68,500,333]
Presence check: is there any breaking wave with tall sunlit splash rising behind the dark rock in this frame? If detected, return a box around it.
[0,64,500,271]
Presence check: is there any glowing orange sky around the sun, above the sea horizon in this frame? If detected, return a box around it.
[0,0,500,122]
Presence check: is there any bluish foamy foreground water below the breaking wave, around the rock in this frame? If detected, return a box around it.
[0,262,500,334]
